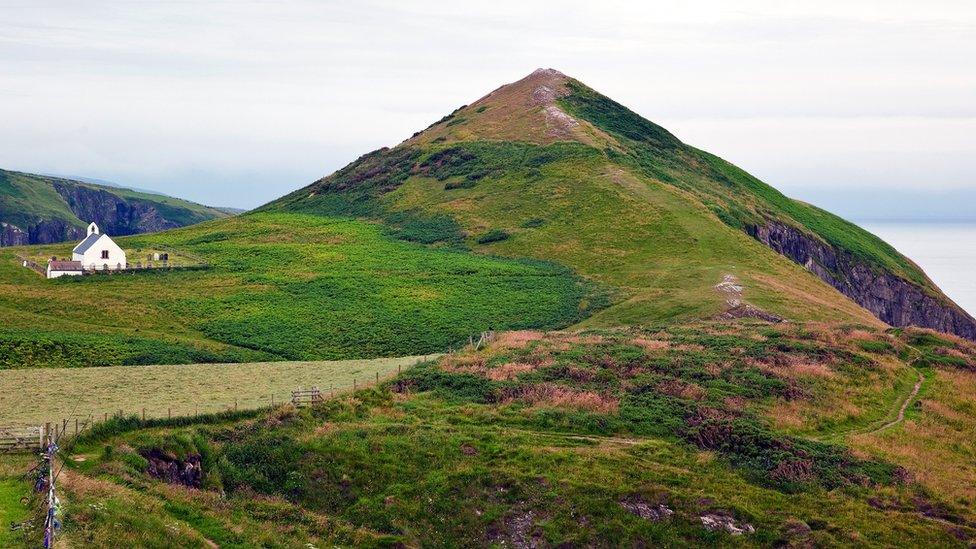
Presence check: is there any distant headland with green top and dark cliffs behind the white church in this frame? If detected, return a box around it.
[0,170,228,246]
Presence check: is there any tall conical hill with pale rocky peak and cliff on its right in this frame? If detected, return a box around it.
[263,69,976,339]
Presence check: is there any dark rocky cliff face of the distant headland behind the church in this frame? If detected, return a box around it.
[54,182,180,236]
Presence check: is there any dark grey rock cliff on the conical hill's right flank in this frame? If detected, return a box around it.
[748,221,976,340]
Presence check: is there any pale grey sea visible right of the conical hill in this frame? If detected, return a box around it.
[856,221,976,316]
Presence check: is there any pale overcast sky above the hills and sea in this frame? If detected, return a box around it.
[0,0,976,214]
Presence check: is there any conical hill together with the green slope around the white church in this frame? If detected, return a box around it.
[0,71,976,367]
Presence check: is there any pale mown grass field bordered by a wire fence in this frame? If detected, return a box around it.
[0,357,422,425]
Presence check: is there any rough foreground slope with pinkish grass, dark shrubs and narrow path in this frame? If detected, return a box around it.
[51,323,976,547]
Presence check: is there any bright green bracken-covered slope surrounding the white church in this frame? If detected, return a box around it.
[0,214,600,368]
